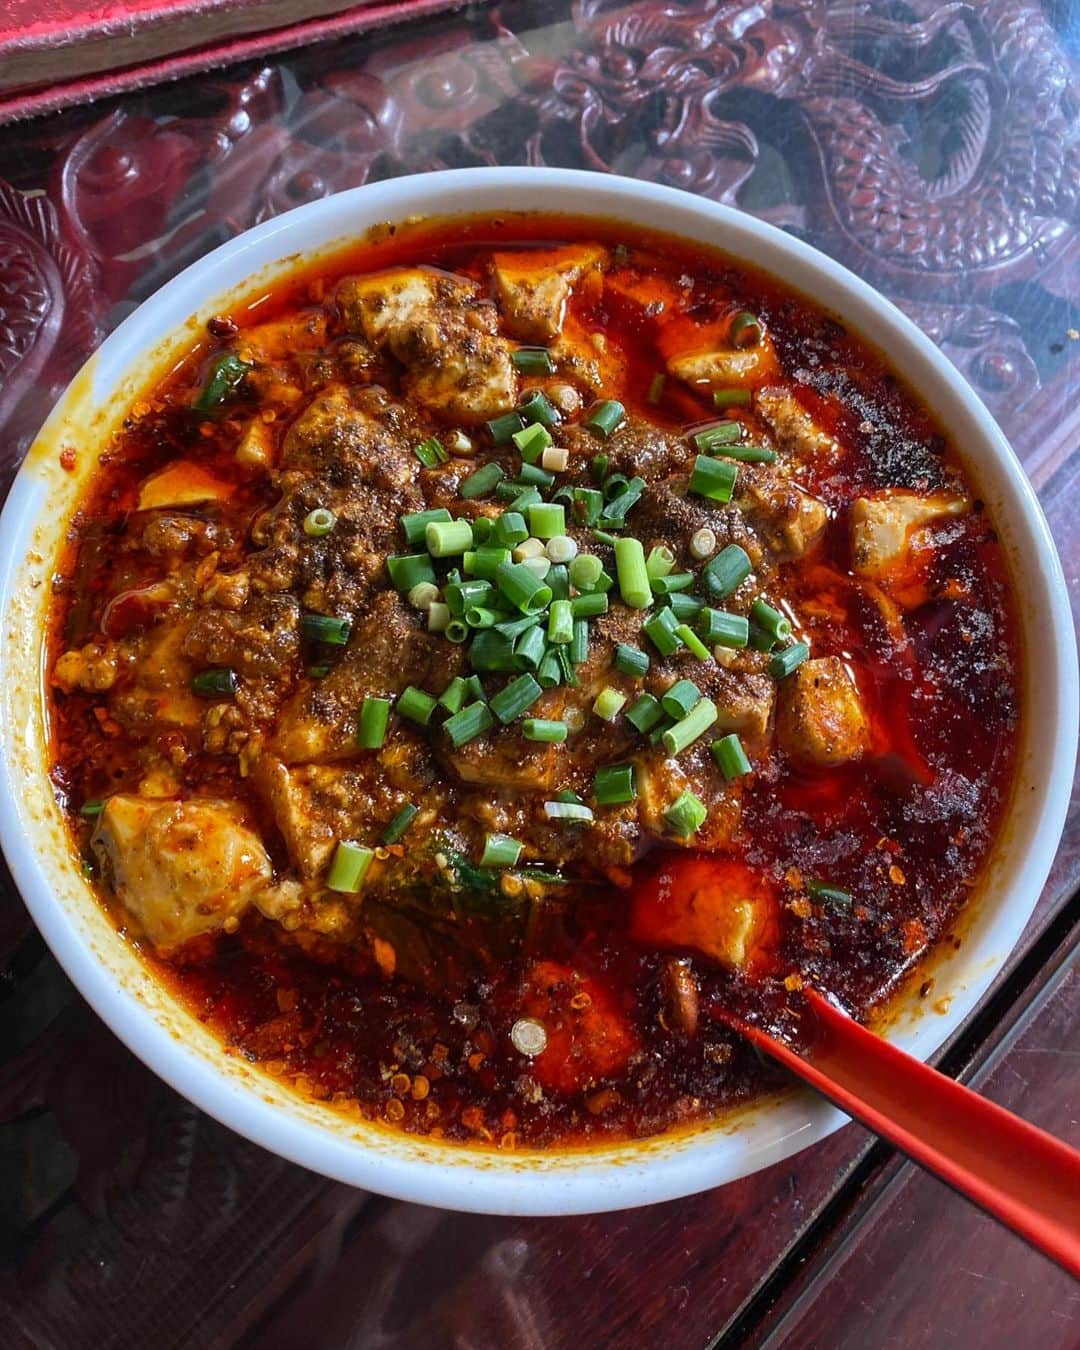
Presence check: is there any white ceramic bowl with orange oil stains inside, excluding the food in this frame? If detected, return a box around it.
[0,169,1077,1214]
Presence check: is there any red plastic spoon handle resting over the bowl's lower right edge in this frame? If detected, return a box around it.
[738,990,1080,1277]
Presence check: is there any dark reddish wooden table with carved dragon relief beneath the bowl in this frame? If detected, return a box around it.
[0,0,1080,1350]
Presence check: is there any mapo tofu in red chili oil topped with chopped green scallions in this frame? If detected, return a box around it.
[47,215,1019,1149]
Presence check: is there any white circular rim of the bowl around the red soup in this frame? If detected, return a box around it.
[0,167,1080,1215]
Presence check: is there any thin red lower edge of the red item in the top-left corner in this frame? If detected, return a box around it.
[0,0,467,124]
